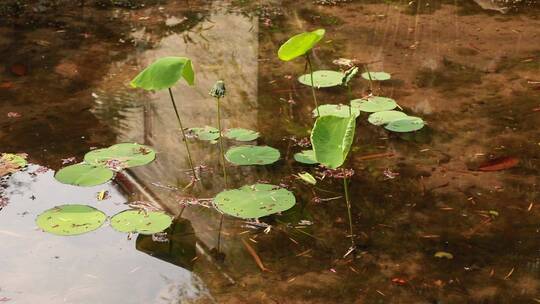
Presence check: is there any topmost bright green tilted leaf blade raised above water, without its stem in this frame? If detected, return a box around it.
[278,29,325,61]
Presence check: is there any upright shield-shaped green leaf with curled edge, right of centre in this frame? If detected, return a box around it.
[311,116,356,169]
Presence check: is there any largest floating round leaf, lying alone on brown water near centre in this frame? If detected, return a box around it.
[214,184,296,219]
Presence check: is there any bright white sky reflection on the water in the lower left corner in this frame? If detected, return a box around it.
[0,165,211,304]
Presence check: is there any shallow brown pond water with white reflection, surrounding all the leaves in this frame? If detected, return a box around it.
[0,0,540,304]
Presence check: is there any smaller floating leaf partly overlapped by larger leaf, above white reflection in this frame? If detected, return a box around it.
[54,163,114,187]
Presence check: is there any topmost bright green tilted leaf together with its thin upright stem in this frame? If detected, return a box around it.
[278,29,326,116]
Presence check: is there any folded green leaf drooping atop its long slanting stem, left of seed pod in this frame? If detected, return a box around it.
[131,57,197,179]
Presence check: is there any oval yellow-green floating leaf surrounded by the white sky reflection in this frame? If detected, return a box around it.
[36,205,107,235]
